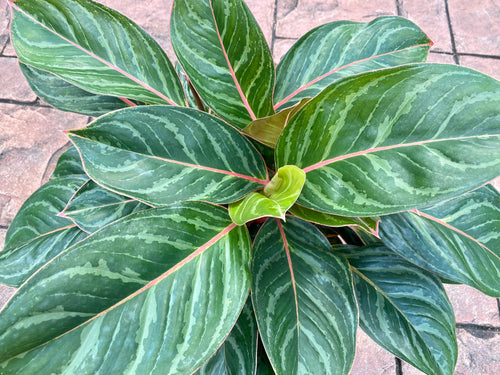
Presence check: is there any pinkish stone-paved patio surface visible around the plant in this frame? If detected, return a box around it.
[0,0,500,375]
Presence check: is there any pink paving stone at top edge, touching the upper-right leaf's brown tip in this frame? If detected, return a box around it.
[394,0,452,52]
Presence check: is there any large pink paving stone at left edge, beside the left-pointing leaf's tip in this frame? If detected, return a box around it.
[0,104,87,226]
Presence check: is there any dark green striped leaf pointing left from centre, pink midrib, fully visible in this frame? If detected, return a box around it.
[69,106,268,205]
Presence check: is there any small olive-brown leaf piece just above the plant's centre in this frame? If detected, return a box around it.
[243,98,311,148]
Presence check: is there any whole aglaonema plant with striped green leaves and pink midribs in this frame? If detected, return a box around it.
[0,0,500,375]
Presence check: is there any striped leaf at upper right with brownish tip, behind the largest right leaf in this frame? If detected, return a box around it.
[274,17,432,108]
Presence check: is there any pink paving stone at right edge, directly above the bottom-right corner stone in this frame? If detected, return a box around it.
[445,284,500,327]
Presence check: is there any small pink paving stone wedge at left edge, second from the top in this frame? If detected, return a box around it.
[0,57,36,102]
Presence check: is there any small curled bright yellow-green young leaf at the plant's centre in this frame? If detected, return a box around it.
[229,165,306,225]
